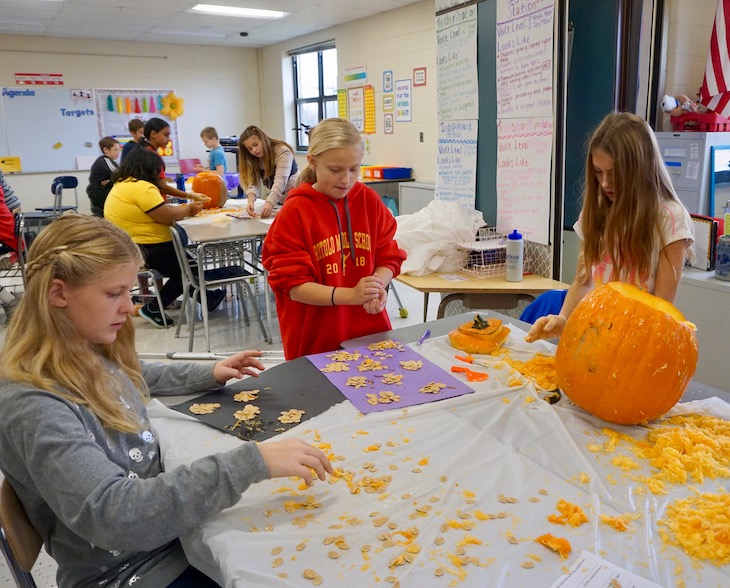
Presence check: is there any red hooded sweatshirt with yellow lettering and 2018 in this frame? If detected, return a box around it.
[263,182,406,359]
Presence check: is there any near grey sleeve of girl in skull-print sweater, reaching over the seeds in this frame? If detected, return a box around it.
[0,389,270,551]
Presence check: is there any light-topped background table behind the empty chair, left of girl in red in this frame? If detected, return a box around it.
[177,212,273,351]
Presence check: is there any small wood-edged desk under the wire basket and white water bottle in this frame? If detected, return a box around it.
[396,272,570,322]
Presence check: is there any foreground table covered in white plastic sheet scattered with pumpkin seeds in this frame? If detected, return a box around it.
[149,311,730,588]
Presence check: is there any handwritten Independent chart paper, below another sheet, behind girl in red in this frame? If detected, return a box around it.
[436,120,479,208]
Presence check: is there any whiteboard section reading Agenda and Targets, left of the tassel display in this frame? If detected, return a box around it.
[0,86,100,172]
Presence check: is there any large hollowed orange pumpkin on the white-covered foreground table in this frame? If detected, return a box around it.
[555,282,697,425]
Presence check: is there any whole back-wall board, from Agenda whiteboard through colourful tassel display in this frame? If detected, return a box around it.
[0,86,180,173]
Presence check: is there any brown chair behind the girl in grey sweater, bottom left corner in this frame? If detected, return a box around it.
[0,479,43,588]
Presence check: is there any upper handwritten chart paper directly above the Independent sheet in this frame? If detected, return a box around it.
[436,4,479,120]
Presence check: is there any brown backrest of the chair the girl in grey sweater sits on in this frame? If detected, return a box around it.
[0,479,43,572]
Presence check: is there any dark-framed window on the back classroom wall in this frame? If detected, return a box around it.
[290,42,337,151]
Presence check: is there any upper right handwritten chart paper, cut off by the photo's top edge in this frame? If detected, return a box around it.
[497,0,554,118]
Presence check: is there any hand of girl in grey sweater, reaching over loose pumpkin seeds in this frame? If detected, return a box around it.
[258,439,333,486]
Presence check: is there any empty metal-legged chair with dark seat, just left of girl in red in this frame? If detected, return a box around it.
[170,225,269,351]
